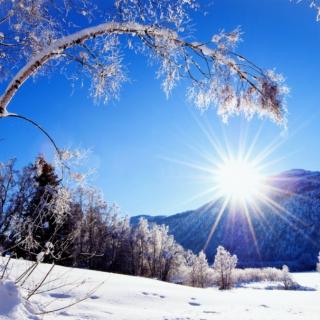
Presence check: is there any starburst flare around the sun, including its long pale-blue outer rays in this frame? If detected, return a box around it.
[164,119,312,253]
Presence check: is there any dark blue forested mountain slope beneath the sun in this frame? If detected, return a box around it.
[131,169,320,271]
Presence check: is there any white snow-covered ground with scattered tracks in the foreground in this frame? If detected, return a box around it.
[0,261,320,320]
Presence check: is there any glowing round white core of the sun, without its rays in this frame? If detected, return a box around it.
[216,159,264,203]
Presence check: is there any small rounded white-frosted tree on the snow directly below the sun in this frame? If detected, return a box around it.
[213,246,238,290]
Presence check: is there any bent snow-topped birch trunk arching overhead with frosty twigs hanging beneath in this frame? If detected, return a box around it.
[0,22,287,122]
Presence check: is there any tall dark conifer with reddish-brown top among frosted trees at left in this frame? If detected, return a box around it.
[10,156,76,261]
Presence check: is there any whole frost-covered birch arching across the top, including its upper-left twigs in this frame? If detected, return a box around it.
[0,0,288,138]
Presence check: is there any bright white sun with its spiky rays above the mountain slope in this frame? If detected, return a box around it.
[165,127,284,250]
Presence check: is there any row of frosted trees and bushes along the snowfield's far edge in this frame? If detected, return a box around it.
[0,156,318,289]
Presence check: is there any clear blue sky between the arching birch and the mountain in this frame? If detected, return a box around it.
[0,0,320,215]
